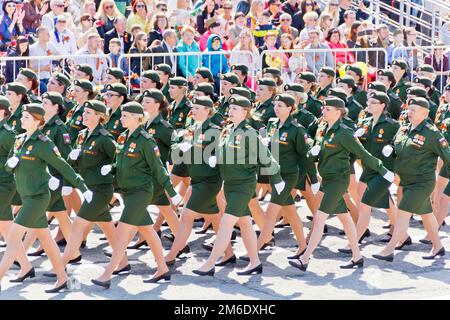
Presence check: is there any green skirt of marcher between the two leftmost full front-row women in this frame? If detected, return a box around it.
[78,184,114,222]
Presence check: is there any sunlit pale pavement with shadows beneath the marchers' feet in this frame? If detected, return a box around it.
[0,188,450,299]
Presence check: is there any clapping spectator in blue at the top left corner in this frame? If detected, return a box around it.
[0,0,25,51]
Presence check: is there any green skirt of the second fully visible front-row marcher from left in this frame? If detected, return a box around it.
[120,184,153,227]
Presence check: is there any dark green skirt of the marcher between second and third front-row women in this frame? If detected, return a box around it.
[186,176,222,214]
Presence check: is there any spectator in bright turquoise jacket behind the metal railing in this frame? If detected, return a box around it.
[177,26,201,83]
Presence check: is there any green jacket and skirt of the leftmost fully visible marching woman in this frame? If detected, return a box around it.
[7,130,87,229]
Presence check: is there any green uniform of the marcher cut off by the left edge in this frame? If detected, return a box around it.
[0,119,16,221]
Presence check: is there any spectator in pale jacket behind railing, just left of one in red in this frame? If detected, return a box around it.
[305,28,334,74]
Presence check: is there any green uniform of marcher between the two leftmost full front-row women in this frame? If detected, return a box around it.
[69,124,116,222]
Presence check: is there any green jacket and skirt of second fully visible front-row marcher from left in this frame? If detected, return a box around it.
[115,126,176,226]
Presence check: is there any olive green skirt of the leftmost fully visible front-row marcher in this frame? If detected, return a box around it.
[14,191,50,229]
